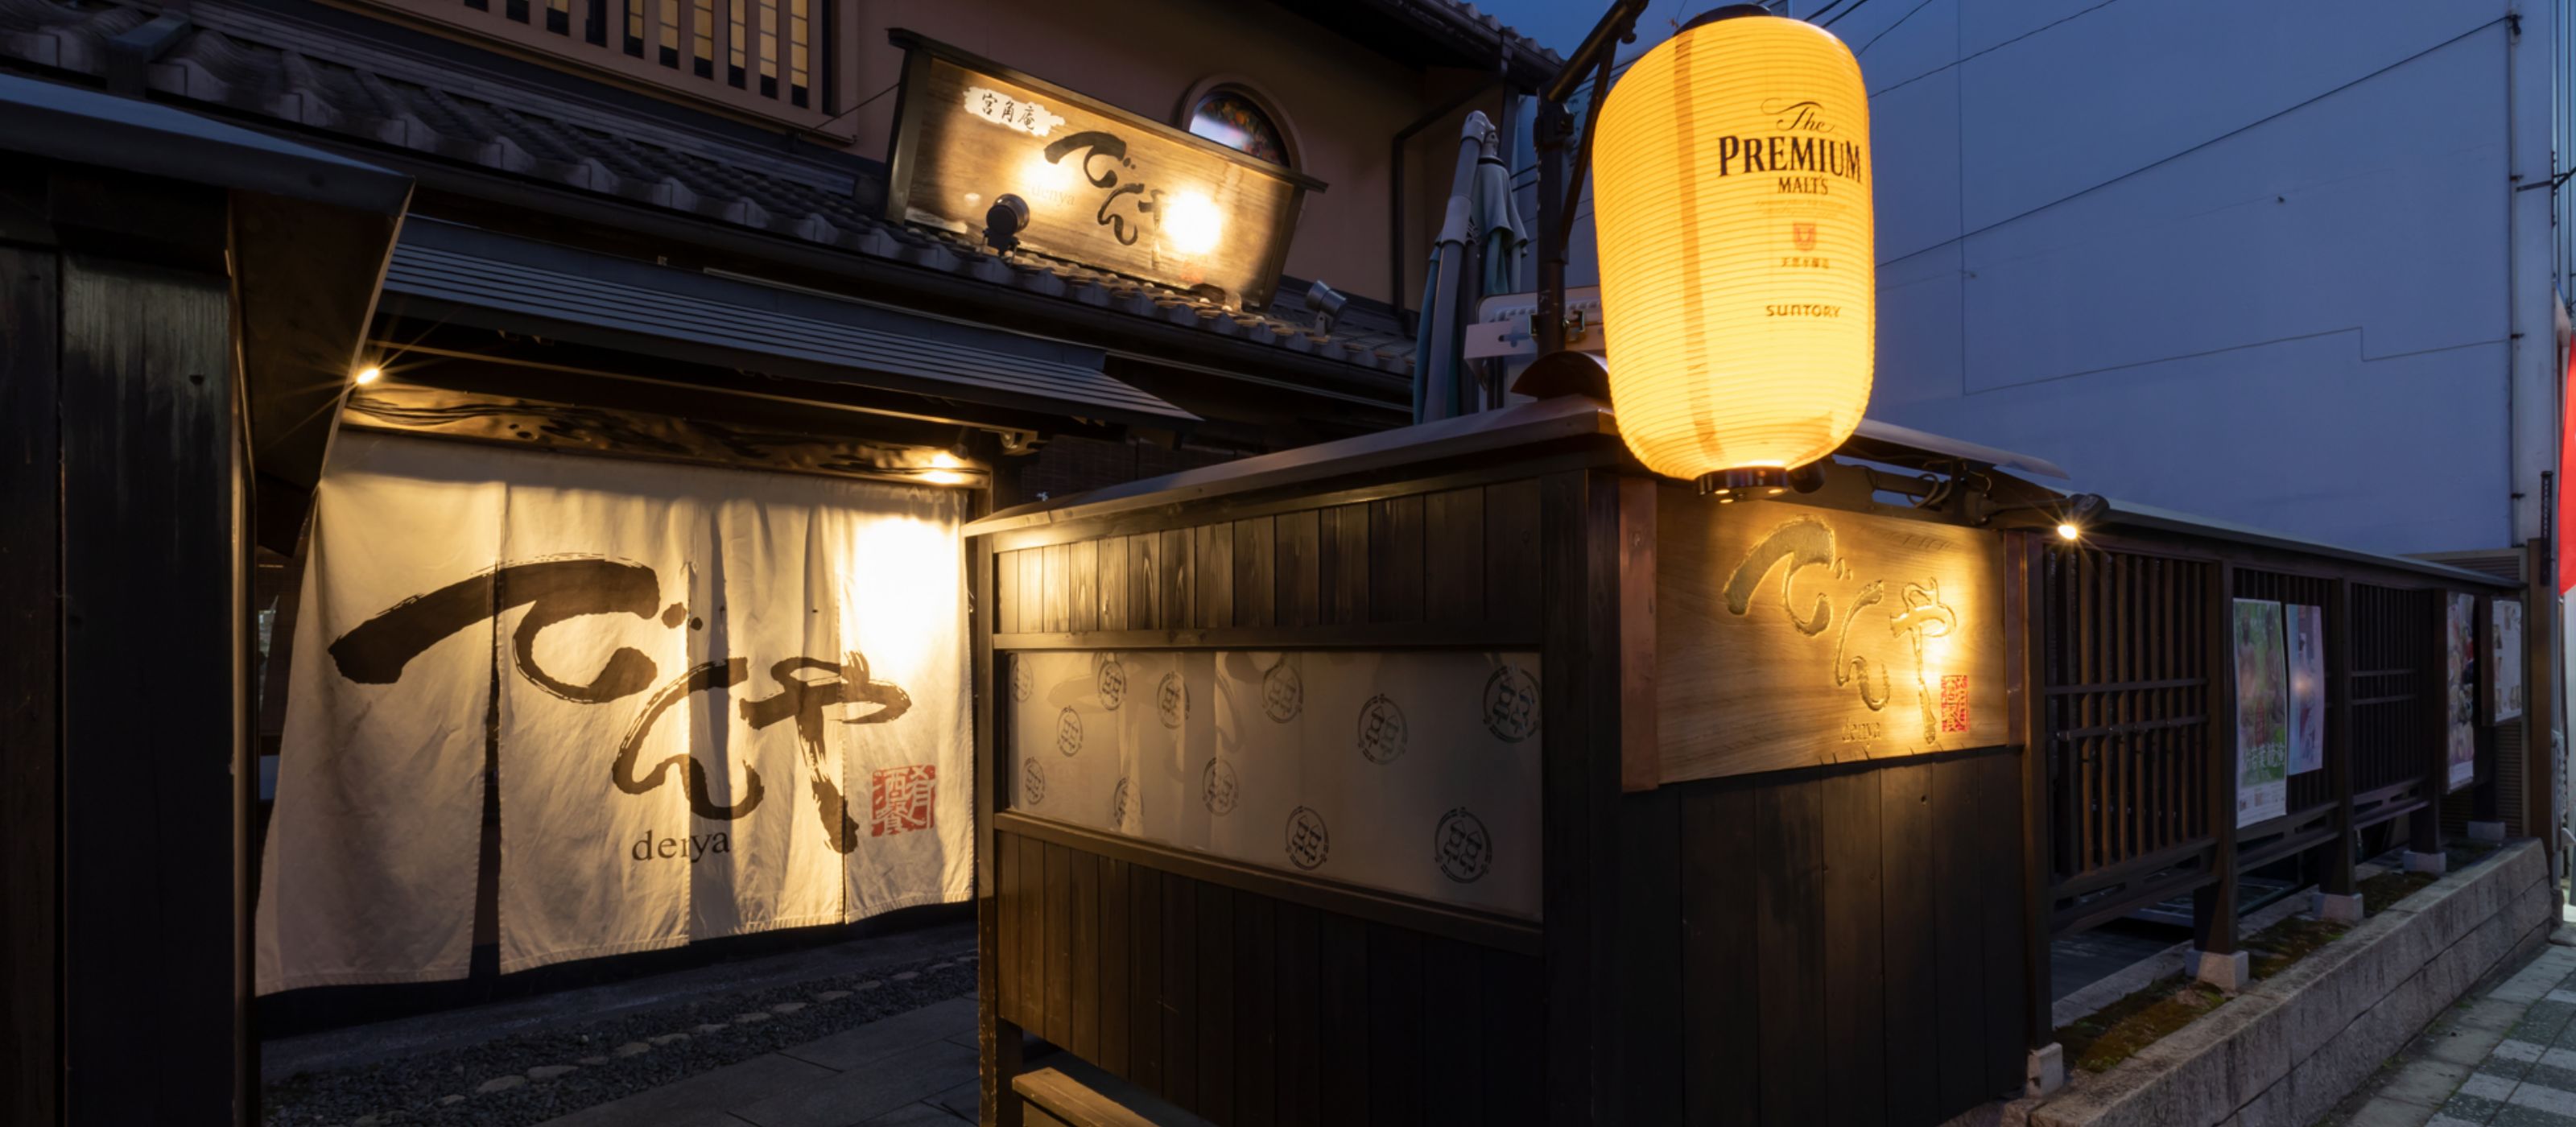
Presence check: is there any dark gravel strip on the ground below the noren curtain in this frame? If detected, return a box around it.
[262,955,974,1127]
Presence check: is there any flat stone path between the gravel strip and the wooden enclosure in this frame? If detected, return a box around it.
[541,996,976,1127]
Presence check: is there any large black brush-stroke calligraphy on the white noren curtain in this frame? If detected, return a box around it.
[330,555,935,854]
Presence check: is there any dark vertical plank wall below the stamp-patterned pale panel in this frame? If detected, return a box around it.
[994,831,1535,1127]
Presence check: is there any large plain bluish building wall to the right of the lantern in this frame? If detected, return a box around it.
[1535,0,2566,553]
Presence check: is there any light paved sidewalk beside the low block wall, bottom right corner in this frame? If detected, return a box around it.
[2326,929,2576,1127]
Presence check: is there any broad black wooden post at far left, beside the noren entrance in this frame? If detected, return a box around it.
[58,239,258,1125]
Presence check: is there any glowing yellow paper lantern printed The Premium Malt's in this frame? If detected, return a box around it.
[1592,5,1878,499]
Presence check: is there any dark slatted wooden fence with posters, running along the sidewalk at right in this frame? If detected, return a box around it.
[2027,535,2548,998]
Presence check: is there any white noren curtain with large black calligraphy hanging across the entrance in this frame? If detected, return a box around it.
[258,432,974,993]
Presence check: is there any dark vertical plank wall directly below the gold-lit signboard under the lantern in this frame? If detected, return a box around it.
[1620,749,2025,1127]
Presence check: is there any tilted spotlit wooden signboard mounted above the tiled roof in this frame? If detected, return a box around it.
[886,31,1324,309]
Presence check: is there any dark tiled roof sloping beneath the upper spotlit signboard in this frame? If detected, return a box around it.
[0,0,1411,376]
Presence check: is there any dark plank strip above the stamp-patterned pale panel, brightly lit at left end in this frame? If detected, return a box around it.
[994,479,1538,643]
